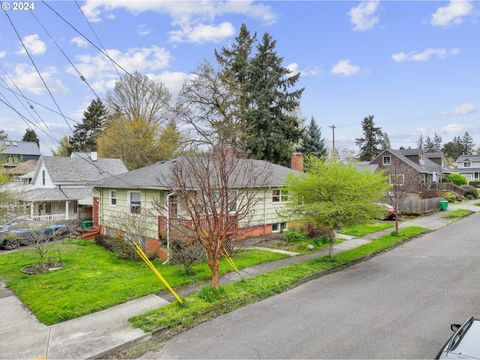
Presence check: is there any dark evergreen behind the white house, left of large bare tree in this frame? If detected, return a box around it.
[70,99,107,151]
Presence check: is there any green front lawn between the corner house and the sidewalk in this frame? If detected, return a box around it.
[0,240,288,325]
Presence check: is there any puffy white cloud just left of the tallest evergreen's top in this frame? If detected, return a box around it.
[169,21,235,44]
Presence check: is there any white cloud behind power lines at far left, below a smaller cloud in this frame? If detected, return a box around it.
[8,64,68,95]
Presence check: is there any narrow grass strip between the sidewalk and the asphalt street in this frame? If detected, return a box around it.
[130,226,427,334]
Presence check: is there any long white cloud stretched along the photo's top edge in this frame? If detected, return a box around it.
[82,0,277,24]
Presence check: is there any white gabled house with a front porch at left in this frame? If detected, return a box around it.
[19,153,128,221]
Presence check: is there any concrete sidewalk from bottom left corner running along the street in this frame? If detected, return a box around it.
[0,201,472,359]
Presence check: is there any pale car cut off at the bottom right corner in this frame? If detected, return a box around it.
[436,317,480,359]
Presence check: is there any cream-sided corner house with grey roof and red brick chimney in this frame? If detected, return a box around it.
[93,153,303,258]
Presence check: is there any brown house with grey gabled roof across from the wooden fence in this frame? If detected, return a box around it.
[370,149,451,191]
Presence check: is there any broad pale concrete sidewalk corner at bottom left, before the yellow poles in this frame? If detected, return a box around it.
[0,287,168,359]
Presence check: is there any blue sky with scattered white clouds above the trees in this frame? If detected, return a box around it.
[0,0,480,153]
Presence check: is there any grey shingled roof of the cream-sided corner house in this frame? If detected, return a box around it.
[95,158,300,190]
